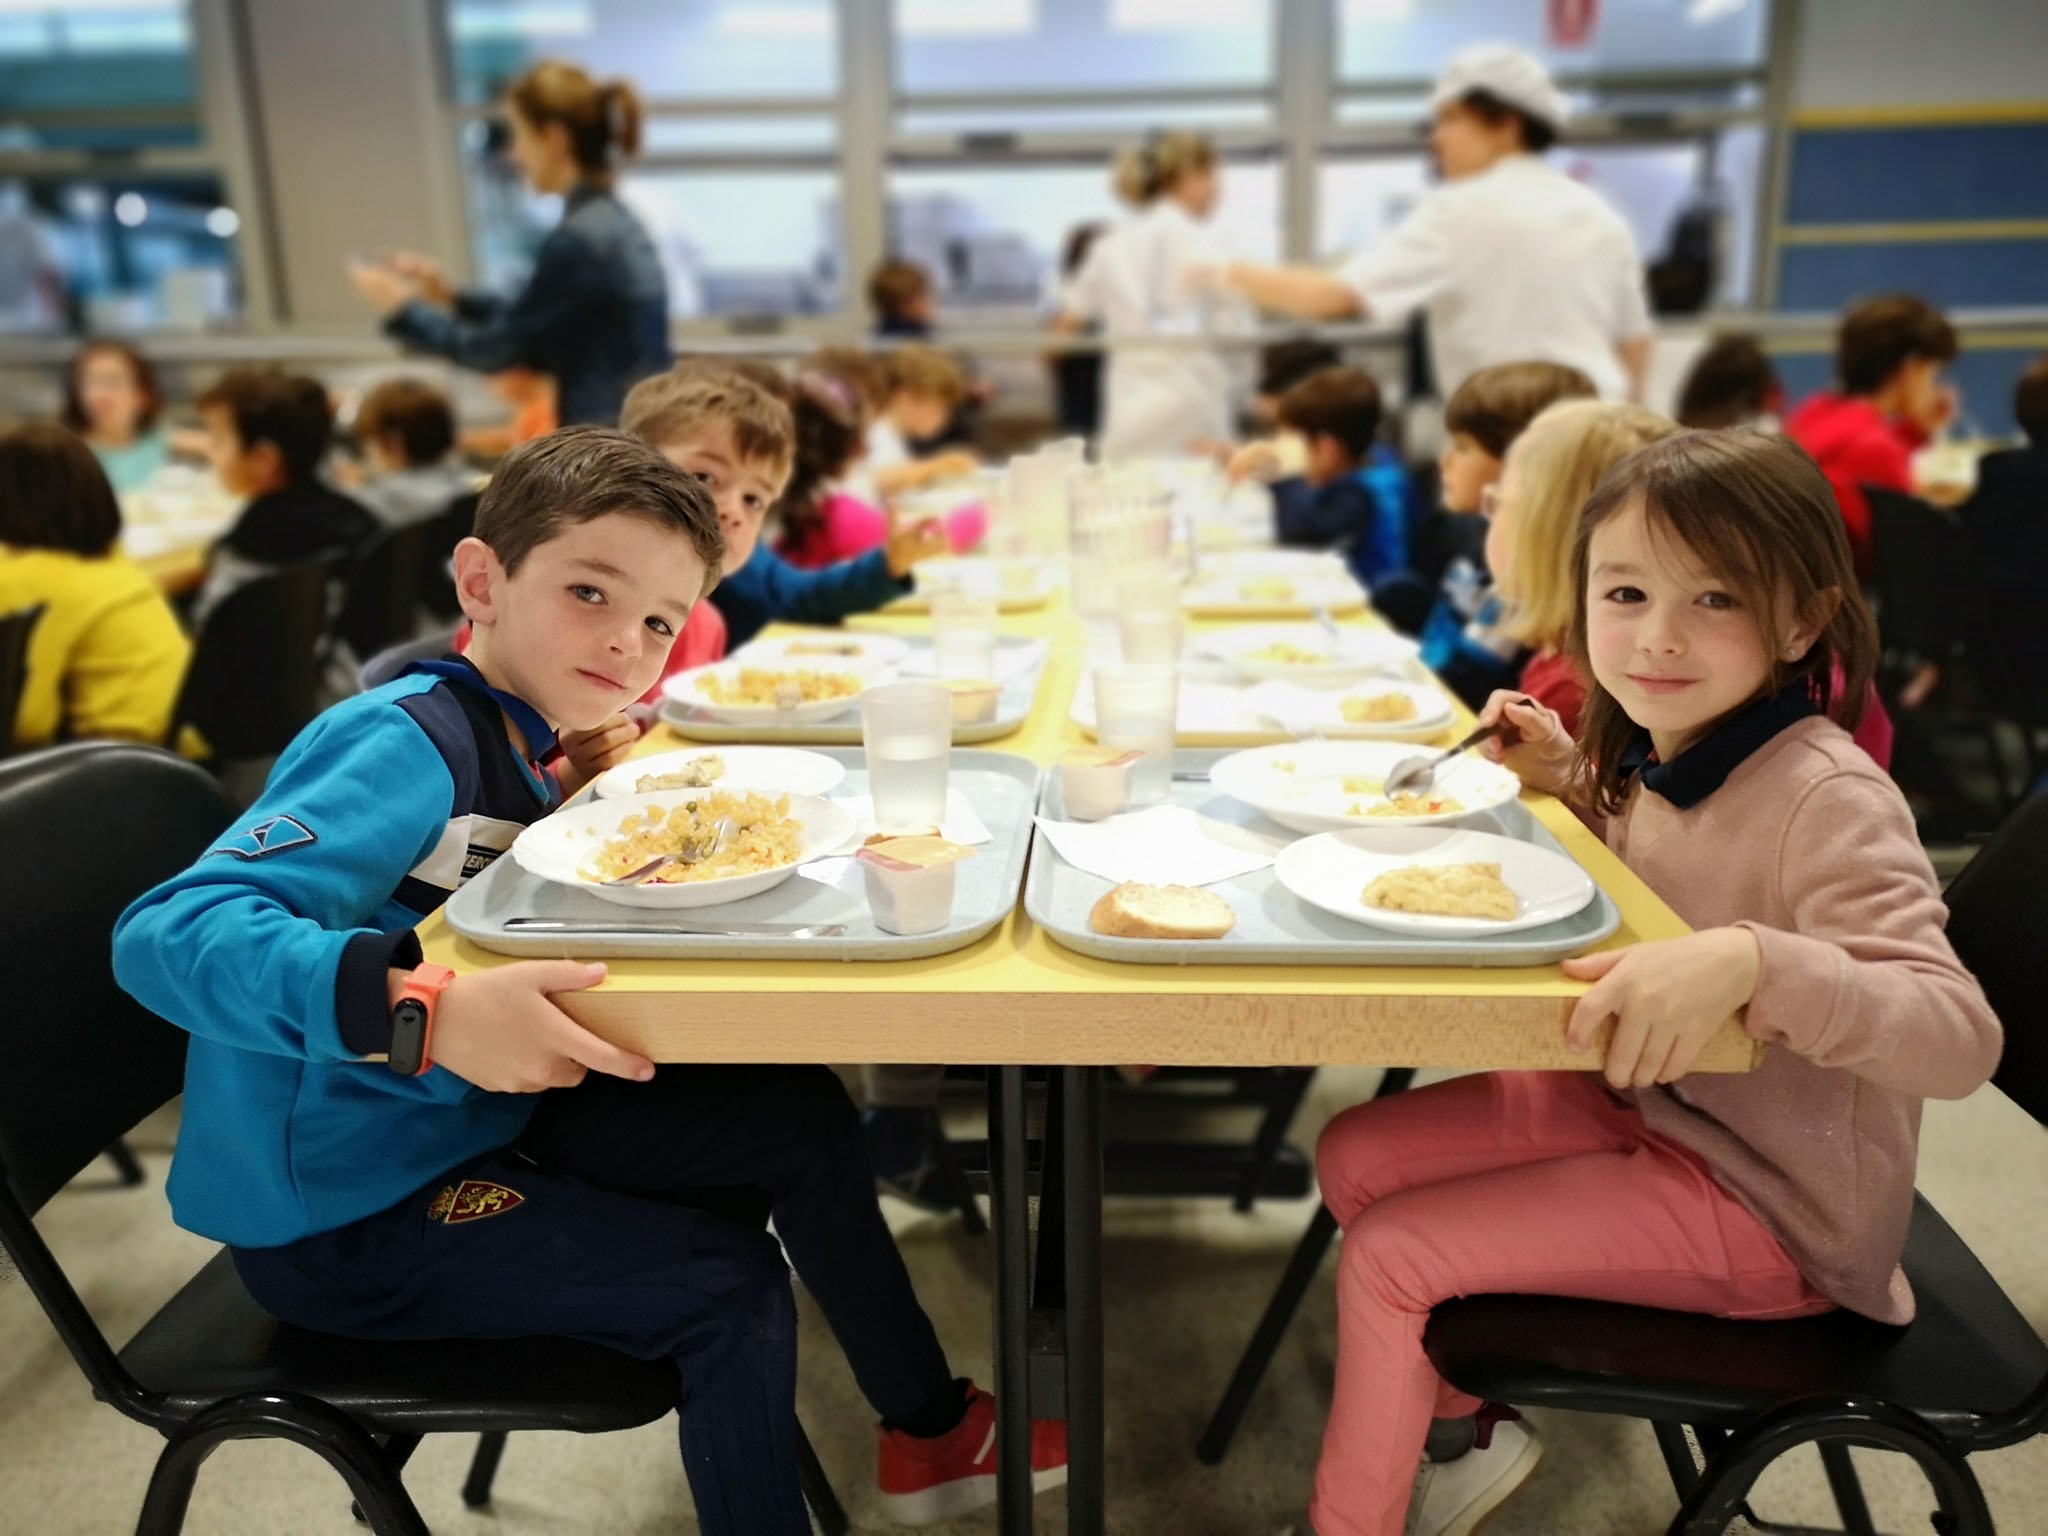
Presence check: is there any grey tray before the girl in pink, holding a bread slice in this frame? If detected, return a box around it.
[1024,750,1622,965]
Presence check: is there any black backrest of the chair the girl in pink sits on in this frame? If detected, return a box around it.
[1948,795,2048,1124]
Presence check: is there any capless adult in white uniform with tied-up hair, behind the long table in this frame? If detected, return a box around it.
[1055,133,1241,461]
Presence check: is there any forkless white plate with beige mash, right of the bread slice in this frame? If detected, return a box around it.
[1274,827,1593,938]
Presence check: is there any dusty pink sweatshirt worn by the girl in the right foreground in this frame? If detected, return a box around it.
[1608,717,2003,1323]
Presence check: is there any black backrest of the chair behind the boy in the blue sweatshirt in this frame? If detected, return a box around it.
[0,741,233,1210]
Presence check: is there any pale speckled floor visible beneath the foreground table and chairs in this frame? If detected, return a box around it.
[0,1071,2048,1536]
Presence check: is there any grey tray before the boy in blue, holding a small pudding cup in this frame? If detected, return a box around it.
[456,750,1038,961]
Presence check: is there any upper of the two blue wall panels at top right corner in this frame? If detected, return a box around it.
[1786,123,2048,223]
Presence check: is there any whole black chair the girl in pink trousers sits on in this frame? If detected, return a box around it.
[1423,797,2048,1536]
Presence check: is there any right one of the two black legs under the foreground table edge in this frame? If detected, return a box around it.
[1073,1067,1104,1536]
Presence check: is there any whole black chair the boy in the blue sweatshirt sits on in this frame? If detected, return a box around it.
[0,743,846,1536]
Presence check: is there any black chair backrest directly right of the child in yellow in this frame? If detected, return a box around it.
[168,559,336,762]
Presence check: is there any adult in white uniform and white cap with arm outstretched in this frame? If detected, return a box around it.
[1223,43,1651,399]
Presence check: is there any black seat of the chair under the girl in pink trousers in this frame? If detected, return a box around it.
[1423,1198,2048,1448]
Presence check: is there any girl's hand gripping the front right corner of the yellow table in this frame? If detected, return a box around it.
[1565,928,1763,1087]
